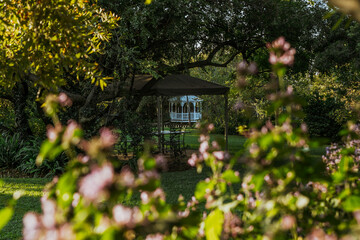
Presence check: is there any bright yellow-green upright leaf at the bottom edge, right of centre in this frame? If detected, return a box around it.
[205,209,224,240]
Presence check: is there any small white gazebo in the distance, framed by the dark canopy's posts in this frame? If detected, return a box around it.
[169,95,203,123]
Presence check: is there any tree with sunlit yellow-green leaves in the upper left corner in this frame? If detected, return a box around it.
[0,0,117,137]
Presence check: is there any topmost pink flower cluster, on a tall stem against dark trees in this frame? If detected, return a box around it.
[266,37,296,66]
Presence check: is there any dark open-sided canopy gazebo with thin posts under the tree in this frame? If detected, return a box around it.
[130,74,229,150]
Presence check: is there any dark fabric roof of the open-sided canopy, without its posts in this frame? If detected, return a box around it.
[133,74,229,96]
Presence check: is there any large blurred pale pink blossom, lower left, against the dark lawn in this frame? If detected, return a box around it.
[79,163,114,201]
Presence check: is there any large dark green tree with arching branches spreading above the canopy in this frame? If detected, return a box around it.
[57,0,325,131]
